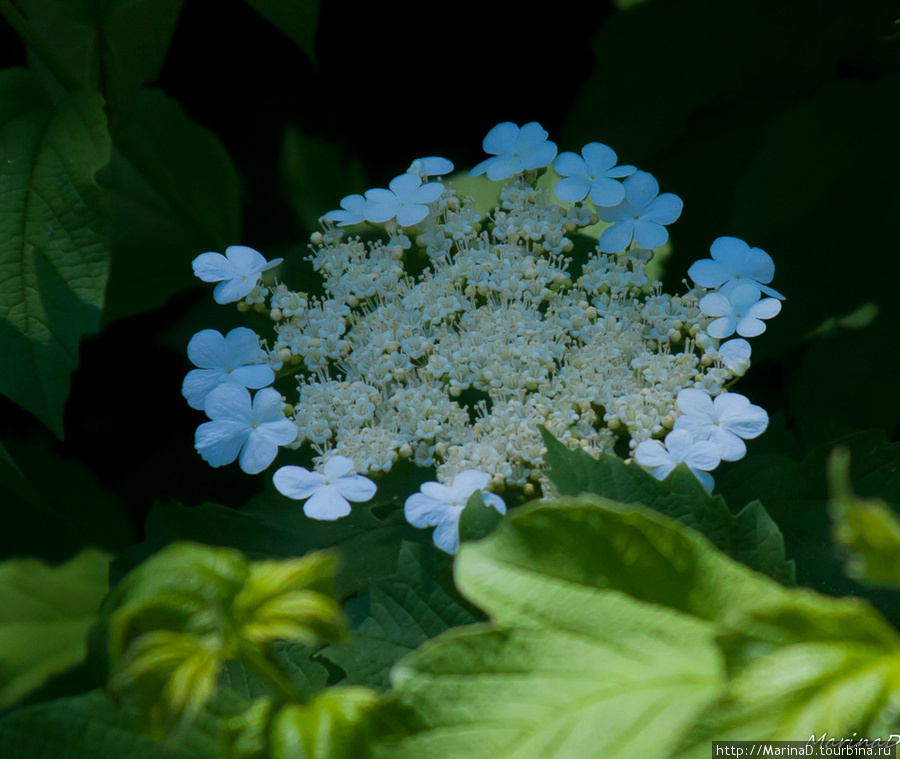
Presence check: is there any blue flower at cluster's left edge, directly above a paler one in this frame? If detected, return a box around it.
[181,327,275,409]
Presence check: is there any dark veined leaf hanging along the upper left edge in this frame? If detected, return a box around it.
[0,69,111,437]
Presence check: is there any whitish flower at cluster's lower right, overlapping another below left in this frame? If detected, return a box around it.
[674,387,769,461]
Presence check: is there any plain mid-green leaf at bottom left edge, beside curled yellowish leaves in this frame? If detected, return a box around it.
[0,549,111,708]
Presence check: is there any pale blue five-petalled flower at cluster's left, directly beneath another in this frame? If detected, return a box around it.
[194,382,297,474]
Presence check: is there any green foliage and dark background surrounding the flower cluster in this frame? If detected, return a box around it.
[0,0,900,759]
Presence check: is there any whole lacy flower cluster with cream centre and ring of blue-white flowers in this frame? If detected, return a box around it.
[184,123,782,551]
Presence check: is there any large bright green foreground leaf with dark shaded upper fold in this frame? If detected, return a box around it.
[384,496,744,759]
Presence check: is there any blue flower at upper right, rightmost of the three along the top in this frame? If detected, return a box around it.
[597,171,684,253]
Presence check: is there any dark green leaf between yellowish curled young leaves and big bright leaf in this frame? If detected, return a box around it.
[321,542,476,690]
